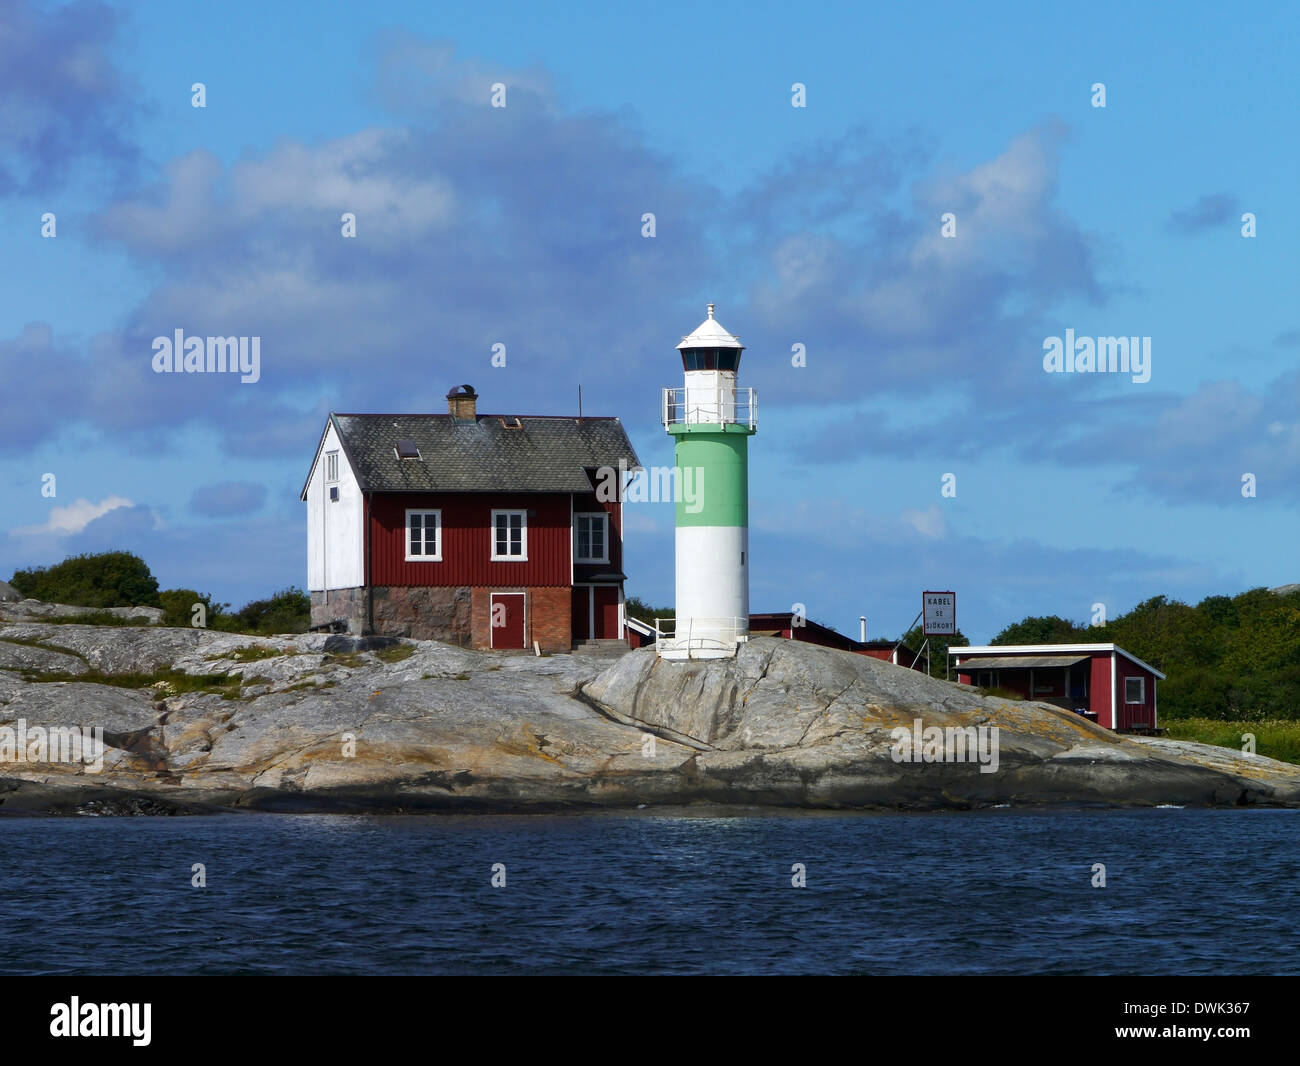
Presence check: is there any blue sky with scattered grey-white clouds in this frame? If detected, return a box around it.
[0,0,1300,641]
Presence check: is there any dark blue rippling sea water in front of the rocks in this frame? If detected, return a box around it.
[0,810,1300,974]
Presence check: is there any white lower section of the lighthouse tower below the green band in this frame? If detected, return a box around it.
[659,525,749,659]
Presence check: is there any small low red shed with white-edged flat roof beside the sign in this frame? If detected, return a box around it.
[948,644,1165,732]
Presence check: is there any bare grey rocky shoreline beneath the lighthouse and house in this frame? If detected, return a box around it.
[0,616,1300,815]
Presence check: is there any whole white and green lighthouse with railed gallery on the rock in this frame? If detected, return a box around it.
[659,304,758,659]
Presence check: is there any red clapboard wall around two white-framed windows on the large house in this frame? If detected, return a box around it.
[371,493,572,588]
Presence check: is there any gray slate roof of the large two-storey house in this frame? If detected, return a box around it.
[322,415,641,493]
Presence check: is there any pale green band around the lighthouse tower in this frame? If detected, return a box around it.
[668,424,753,527]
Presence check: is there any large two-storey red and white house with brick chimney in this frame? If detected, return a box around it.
[302,385,650,651]
